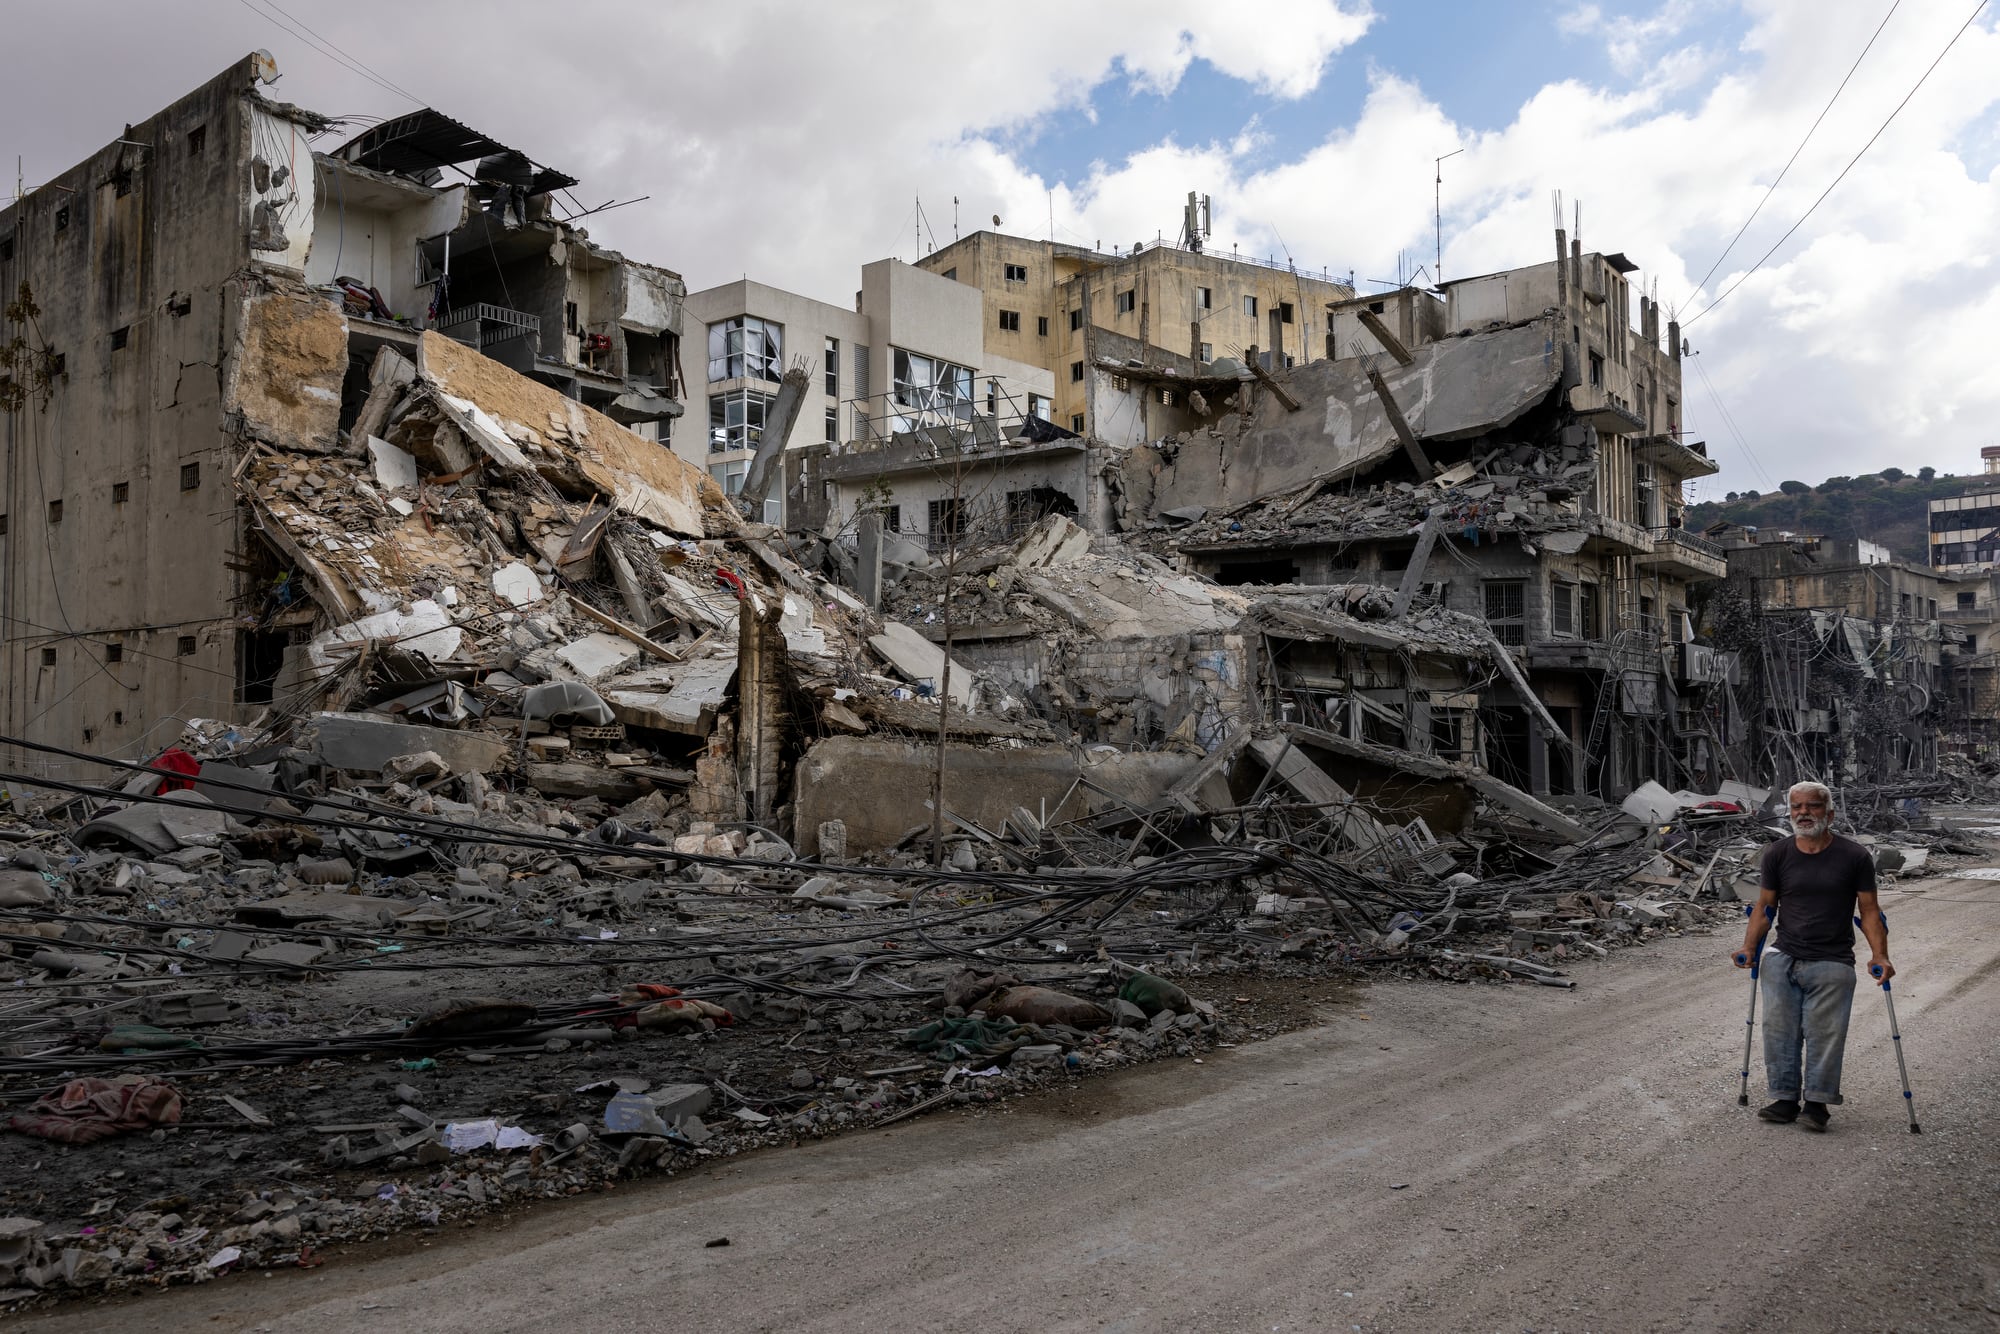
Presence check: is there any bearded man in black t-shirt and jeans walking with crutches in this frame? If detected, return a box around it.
[1734,782,1896,1130]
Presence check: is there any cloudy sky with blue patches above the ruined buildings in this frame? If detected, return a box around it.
[0,0,2000,494]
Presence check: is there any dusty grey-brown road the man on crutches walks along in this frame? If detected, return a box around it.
[22,880,2000,1334]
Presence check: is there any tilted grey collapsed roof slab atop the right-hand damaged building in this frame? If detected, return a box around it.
[1122,318,1564,518]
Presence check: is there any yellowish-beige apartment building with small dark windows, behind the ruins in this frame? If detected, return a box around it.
[916,232,1354,444]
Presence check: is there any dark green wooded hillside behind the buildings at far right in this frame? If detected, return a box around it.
[1688,468,1976,564]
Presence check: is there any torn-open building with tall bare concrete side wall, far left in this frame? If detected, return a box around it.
[0,54,684,754]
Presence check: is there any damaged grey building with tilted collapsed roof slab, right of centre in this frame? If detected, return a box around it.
[1112,232,1740,796]
